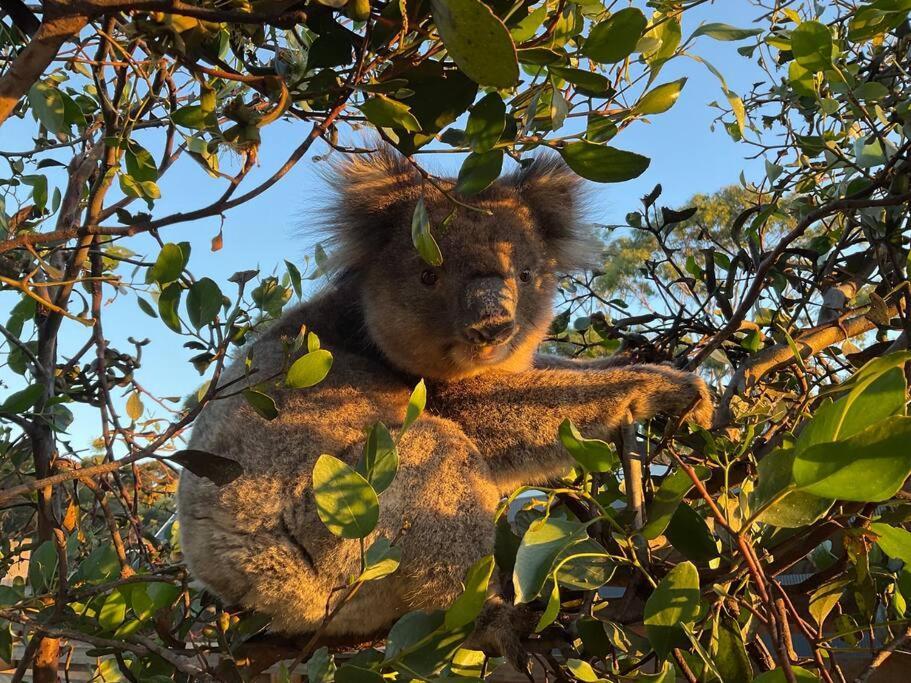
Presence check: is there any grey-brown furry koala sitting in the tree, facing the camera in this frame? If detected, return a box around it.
[178,149,713,656]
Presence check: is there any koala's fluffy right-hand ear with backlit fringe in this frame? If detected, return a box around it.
[511,154,600,270]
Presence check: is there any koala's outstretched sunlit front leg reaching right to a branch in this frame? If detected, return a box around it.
[435,365,714,490]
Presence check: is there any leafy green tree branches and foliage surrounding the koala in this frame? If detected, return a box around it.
[0,0,911,683]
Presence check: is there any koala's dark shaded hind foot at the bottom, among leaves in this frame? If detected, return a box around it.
[465,597,538,675]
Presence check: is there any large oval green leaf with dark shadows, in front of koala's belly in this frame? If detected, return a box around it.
[313,455,380,538]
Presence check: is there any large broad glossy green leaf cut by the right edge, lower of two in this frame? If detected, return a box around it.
[793,415,911,503]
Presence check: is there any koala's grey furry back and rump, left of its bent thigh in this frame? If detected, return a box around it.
[178,292,411,627]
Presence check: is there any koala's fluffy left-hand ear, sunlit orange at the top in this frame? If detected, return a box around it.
[319,144,421,271]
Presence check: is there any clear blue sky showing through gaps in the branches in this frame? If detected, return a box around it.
[0,0,763,454]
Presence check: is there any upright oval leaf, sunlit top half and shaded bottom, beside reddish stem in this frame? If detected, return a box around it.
[643,562,699,659]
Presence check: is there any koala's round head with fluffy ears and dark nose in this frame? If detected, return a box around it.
[327,149,597,379]
